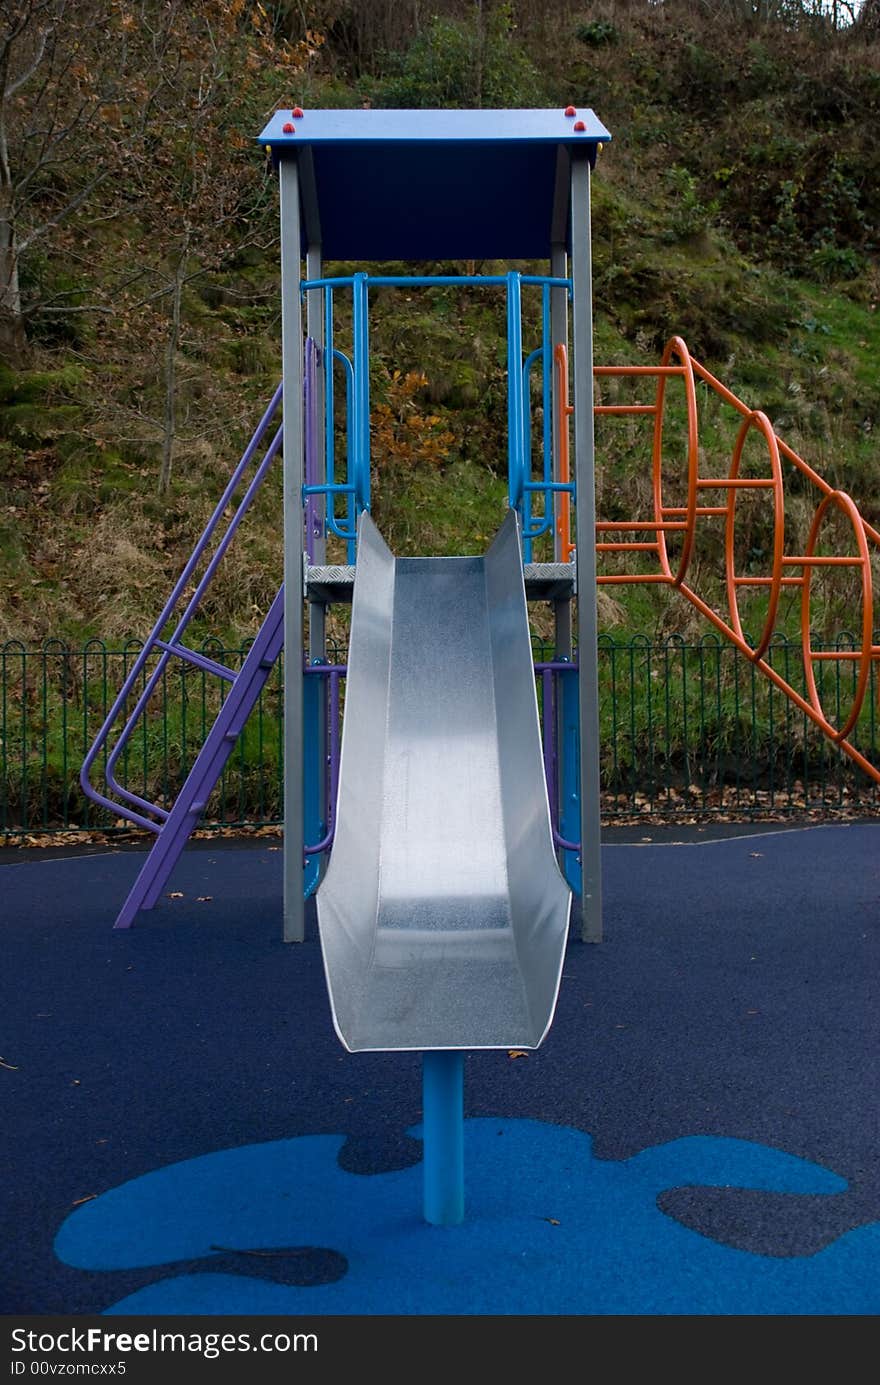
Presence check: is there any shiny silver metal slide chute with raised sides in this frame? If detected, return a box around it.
[317,511,571,1051]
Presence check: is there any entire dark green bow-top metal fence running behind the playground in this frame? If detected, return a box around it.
[0,633,880,839]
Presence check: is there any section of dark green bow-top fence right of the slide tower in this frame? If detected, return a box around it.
[599,632,880,819]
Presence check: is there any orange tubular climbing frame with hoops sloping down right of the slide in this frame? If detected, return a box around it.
[587,337,880,783]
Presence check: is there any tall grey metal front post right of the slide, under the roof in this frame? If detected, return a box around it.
[571,151,601,943]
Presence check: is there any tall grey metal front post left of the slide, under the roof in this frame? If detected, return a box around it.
[285,159,305,943]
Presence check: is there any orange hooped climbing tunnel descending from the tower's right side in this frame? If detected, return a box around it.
[554,337,880,783]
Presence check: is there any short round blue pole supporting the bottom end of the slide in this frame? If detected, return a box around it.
[421,1048,464,1226]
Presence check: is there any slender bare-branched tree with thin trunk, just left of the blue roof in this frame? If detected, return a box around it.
[118,0,320,493]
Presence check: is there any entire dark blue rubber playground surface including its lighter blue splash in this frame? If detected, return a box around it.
[0,823,880,1316]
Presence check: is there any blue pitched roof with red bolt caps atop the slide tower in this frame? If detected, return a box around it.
[259,107,611,260]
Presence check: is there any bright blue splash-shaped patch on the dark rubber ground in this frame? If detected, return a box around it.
[55,1118,880,1316]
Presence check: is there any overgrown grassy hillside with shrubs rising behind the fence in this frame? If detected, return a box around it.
[0,15,880,641]
